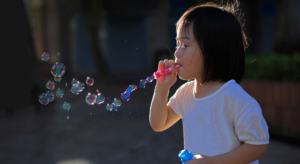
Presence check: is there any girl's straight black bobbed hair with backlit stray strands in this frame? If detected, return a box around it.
[176,1,248,83]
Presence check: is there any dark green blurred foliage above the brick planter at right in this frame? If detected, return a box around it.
[245,53,300,82]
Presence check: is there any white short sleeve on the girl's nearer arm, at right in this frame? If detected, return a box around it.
[235,103,270,145]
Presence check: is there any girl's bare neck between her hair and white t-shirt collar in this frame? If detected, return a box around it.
[194,79,225,98]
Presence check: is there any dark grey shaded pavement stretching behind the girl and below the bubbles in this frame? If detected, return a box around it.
[0,78,300,164]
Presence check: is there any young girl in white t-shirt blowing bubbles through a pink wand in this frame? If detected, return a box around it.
[149,1,269,164]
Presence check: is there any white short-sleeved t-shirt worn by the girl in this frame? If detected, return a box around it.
[168,79,269,164]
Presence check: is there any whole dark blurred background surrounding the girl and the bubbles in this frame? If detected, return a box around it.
[0,0,300,164]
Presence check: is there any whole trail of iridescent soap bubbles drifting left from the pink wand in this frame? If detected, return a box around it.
[39,52,154,111]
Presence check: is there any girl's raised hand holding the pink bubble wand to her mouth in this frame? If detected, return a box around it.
[156,59,178,89]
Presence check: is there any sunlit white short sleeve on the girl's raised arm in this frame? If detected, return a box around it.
[167,83,187,118]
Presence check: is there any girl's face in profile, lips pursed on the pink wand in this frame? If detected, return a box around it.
[174,24,203,80]
